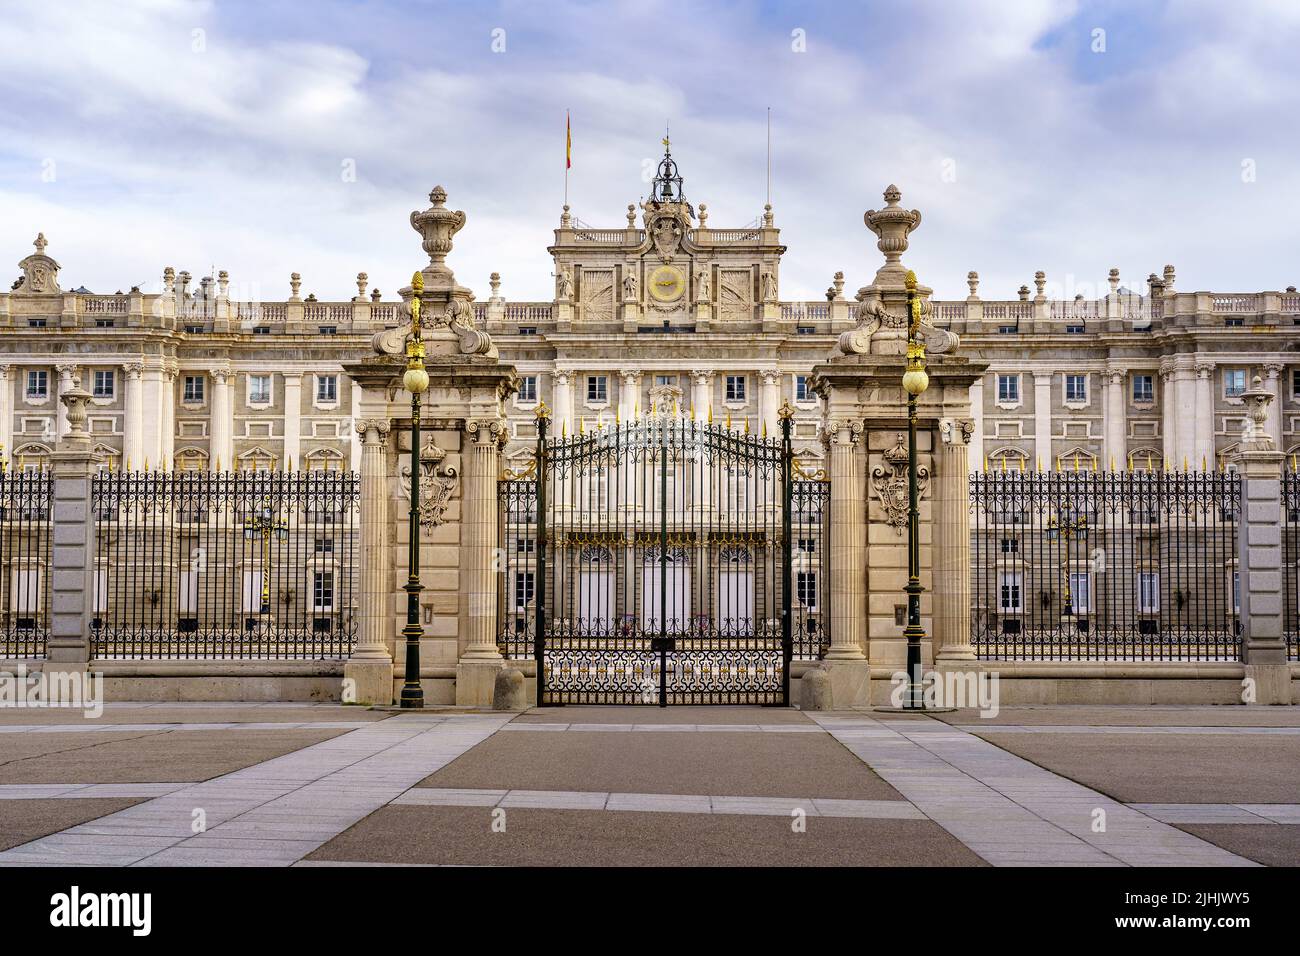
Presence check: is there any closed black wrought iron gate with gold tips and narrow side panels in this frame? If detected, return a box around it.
[498,410,829,706]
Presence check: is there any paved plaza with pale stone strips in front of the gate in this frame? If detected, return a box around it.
[0,704,1300,866]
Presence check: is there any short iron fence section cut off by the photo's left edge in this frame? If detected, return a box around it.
[0,462,51,659]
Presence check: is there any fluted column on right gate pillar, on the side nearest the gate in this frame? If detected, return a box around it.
[826,419,866,661]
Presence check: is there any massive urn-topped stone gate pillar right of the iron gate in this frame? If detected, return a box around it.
[811,186,988,708]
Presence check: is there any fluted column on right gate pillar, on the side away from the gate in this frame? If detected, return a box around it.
[933,419,975,663]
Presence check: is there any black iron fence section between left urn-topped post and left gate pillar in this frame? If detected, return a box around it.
[91,471,359,659]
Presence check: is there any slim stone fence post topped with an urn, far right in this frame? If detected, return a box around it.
[1236,376,1291,704]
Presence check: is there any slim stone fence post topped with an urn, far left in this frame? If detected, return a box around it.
[44,378,100,675]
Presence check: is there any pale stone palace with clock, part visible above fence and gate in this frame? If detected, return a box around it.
[0,155,1300,471]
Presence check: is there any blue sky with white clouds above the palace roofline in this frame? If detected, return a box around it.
[0,0,1300,299]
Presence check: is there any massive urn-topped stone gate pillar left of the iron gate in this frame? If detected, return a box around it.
[345,186,519,706]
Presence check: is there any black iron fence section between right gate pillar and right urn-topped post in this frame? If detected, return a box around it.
[970,472,1240,661]
